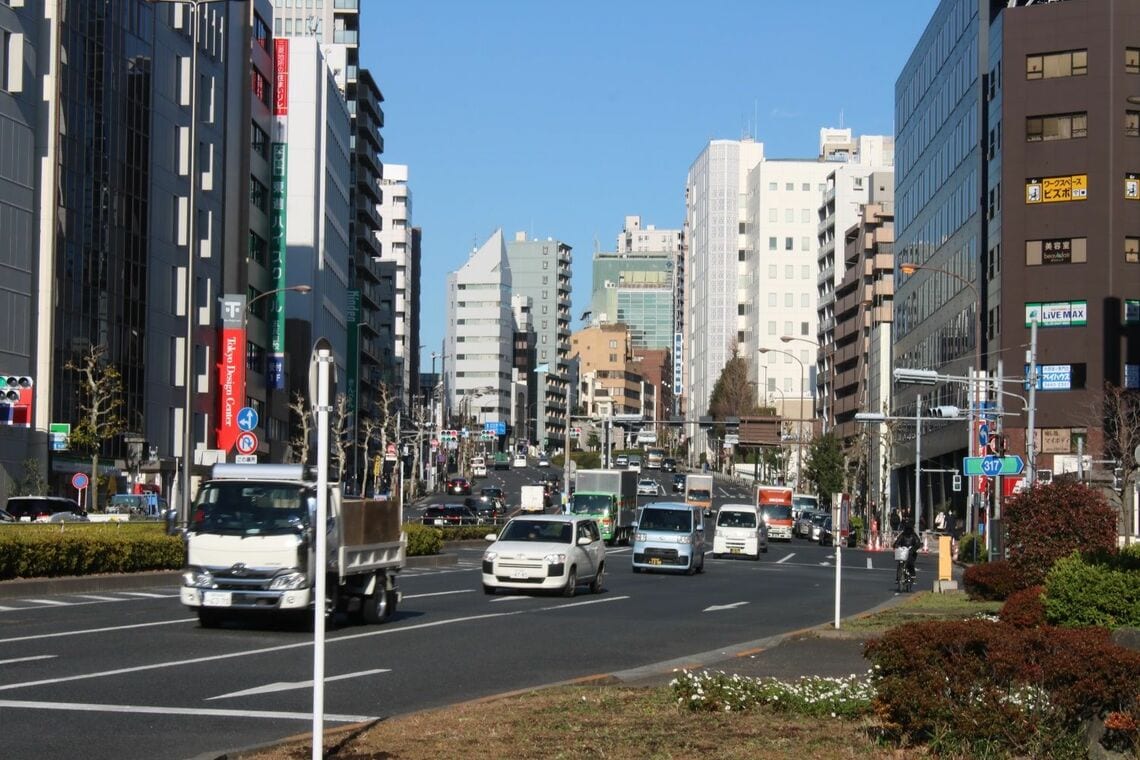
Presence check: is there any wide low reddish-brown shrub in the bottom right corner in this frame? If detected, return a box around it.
[864,620,1140,757]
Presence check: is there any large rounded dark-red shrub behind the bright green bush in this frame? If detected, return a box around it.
[1004,481,1116,586]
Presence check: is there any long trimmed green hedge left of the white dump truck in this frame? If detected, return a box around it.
[0,522,185,580]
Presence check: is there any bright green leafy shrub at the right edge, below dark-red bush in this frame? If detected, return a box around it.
[1044,551,1140,628]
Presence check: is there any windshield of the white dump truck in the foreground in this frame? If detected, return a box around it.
[190,481,317,536]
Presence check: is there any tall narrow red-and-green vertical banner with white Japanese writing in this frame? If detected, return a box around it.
[266,39,288,391]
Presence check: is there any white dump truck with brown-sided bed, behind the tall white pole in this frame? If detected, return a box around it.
[181,464,407,628]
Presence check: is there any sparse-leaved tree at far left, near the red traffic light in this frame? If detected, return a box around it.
[65,345,127,508]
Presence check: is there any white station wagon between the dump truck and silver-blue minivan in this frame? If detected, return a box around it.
[482,515,605,596]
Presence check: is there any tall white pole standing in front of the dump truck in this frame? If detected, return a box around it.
[312,349,333,760]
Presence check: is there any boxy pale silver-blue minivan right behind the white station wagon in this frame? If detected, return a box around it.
[633,501,705,575]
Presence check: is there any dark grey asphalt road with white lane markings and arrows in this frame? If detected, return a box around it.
[0,473,916,760]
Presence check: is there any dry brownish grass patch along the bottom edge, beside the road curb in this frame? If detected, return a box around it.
[239,686,928,760]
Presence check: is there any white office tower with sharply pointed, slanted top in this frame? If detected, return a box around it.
[443,229,514,430]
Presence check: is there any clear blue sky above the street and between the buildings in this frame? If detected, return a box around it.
[360,0,937,371]
